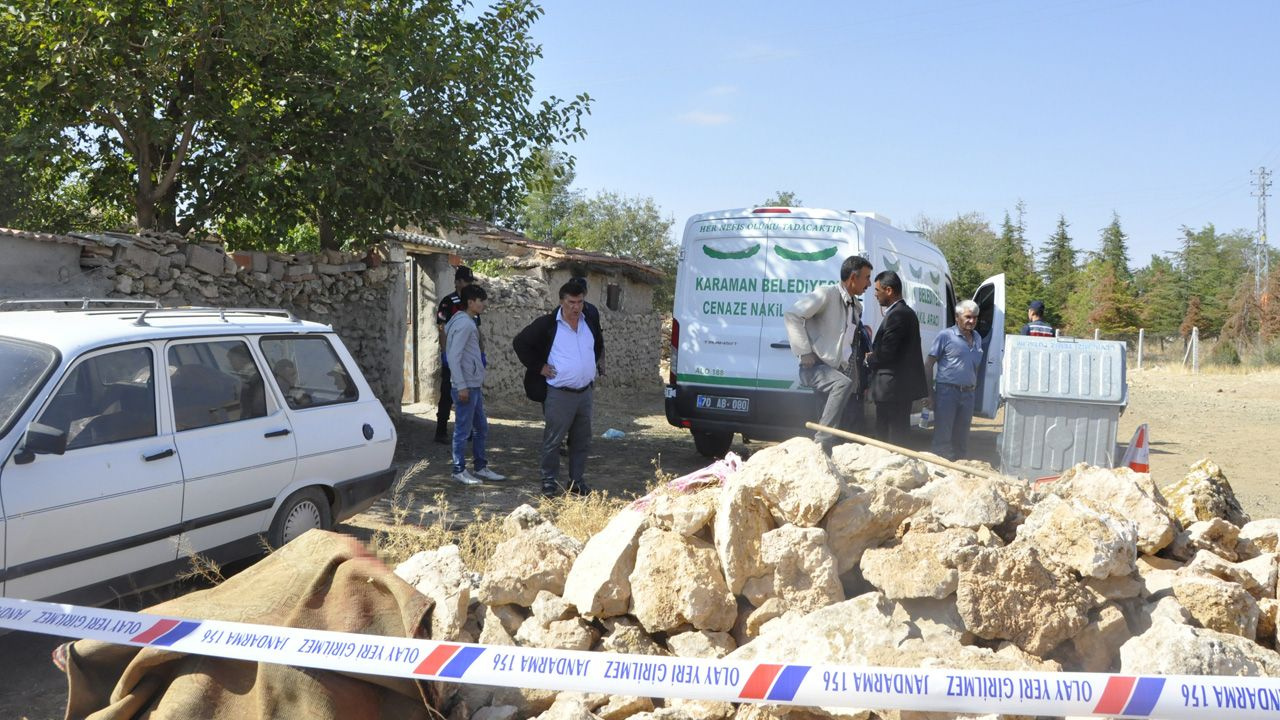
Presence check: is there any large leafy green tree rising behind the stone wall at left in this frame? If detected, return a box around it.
[0,0,590,246]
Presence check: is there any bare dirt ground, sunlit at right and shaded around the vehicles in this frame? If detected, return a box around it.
[0,368,1280,720]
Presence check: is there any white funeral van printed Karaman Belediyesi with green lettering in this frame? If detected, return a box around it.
[666,208,1005,457]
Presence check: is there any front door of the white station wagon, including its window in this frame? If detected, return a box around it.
[0,345,182,598]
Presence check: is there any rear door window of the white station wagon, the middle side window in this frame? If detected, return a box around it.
[169,340,266,432]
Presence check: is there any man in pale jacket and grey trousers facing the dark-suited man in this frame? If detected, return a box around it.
[783,255,872,452]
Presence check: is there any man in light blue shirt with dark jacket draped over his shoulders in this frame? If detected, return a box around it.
[512,281,604,497]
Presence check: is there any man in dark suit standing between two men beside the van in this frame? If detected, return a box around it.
[867,270,929,445]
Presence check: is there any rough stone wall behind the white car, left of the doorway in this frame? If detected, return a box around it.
[81,228,406,414]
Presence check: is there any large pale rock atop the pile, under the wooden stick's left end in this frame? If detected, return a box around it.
[733,437,844,528]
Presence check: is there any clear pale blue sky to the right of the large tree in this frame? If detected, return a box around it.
[534,0,1280,266]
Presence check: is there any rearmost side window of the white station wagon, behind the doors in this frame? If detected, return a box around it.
[259,336,360,410]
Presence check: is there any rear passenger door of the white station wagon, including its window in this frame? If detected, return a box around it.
[165,338,297,553]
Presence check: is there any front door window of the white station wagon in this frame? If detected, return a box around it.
[36,347,156,450]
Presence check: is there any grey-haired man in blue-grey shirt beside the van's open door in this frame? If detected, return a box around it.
[924,300,983,460]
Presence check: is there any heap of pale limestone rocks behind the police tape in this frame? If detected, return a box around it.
[397,438,1280,720]
